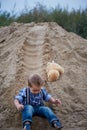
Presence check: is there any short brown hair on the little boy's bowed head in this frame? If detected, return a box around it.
[28,74,44,87]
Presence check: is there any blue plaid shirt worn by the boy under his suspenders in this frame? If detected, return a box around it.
[15,87,52,106]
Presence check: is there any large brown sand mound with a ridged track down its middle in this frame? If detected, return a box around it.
[0,23,87,130]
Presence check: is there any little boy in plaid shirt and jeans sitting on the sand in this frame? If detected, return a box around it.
[14,74,62,130]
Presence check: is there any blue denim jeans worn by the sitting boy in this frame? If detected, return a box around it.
[22,105,61,126]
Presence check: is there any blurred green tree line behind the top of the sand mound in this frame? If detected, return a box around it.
[0,4,87,39]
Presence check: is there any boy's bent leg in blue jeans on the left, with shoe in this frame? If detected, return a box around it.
[22,105,34,130]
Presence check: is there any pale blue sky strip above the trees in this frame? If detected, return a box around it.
[0,0,87,13]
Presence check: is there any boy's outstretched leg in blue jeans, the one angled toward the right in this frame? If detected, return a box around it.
[38,106,62,128]
